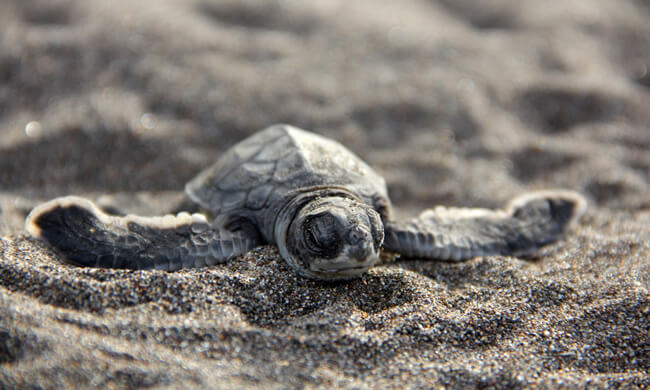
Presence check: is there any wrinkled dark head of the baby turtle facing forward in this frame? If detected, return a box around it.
[276,196,384,280]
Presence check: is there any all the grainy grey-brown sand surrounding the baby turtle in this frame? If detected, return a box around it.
[0,0,650,389]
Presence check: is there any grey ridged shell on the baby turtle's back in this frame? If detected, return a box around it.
[185,125,389,221]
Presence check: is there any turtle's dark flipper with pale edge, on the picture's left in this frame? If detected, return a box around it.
[25,196,261,270]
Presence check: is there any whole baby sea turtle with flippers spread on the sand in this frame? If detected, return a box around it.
[25,125,586,280]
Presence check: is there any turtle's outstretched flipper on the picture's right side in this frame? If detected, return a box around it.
[384,191,586,260]
